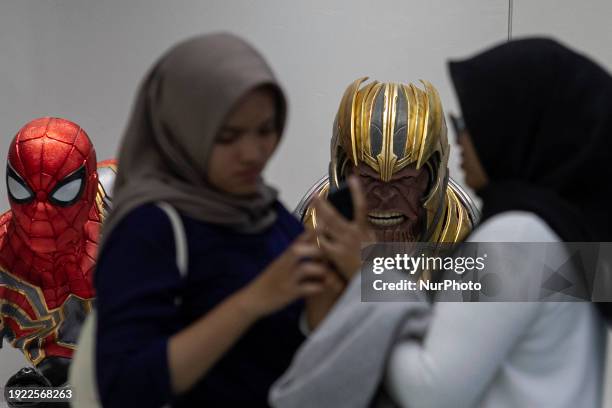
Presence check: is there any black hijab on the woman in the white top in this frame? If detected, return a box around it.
[449,39,612,241]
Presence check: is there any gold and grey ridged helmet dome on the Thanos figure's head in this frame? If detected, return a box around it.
[330,77,449,185]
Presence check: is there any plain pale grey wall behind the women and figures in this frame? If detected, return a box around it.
[0,0,612,404]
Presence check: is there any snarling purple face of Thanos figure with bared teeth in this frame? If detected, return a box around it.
[347,163,429,242]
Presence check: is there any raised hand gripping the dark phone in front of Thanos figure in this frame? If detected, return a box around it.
[315,176,376,281]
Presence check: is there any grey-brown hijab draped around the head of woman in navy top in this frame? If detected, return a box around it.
[103,34,286,245]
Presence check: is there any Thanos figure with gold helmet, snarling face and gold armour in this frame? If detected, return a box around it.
[296,77,479,244]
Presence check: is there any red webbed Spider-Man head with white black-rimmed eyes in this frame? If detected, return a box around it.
[6,118,98,253]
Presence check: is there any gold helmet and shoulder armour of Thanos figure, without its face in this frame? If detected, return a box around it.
[297,77,478,242]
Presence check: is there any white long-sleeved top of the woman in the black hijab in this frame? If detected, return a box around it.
[385,211,606,408]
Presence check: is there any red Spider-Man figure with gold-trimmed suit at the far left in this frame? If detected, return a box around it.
[0,118,117,402]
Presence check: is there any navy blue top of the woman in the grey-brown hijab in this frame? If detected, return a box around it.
[95,203,304,407]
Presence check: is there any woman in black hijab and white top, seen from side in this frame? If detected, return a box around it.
[385,39,612,408]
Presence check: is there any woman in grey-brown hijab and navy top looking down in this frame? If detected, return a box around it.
[95,34,365,407]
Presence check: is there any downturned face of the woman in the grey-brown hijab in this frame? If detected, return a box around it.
[208,88,279,195]
